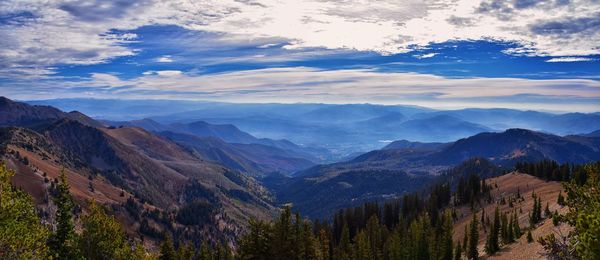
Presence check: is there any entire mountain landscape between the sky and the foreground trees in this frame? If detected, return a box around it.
[7,98,600,239]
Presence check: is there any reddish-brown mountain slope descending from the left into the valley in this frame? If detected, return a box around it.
[0,98,275,245]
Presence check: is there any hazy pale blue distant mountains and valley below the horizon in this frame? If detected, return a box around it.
[29,99,600,157]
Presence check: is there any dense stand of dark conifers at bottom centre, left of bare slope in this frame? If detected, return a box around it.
[239,187,454,260]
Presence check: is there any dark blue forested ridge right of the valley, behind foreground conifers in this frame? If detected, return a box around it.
[263,129,600,218]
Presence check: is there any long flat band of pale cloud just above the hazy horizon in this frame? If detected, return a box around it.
[8,67,600,112]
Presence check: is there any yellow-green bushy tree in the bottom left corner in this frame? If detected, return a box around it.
[0,163,49,259]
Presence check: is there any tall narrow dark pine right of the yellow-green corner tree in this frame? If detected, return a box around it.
[48,169,81,259]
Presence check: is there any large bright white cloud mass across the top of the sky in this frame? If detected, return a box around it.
[0,0,600,75]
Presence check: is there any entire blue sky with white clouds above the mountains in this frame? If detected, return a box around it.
[0,0,600,112]
